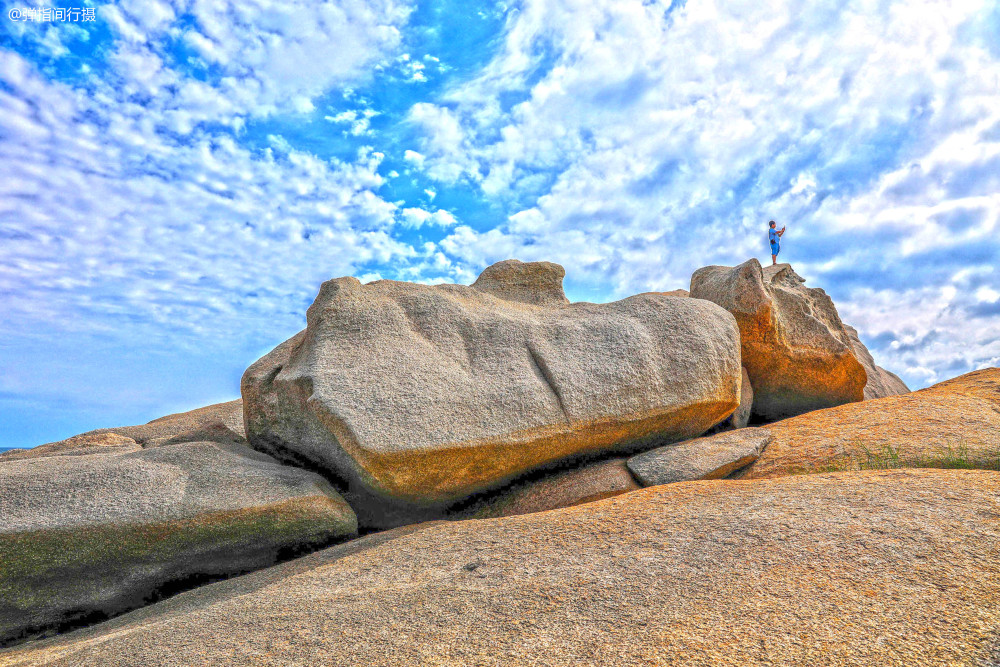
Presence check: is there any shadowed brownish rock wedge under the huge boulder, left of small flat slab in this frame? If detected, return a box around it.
[453,458,641,519]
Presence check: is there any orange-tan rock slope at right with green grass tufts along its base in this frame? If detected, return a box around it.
[746,368,1000,478]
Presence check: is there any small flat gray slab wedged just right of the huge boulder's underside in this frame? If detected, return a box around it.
[627,428,773,486]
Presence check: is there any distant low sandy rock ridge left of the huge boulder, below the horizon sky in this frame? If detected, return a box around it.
[0,399,246,461]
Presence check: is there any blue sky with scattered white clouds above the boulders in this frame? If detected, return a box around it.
[0,0,1000,447]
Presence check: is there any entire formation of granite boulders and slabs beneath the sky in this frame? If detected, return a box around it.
[0,260,944,656]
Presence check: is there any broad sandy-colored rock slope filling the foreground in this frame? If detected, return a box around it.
[0,470,1000,667]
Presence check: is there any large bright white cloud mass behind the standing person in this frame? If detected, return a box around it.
[390,0,1000,381]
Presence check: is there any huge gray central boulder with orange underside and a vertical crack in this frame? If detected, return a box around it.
[242,261,740,527]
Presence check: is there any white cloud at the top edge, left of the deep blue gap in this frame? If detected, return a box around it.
[99,0,411,124]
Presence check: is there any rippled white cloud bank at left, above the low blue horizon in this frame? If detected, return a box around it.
[0,52,418,354]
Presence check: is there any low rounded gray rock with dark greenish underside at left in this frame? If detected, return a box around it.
[0,442,357,644]
